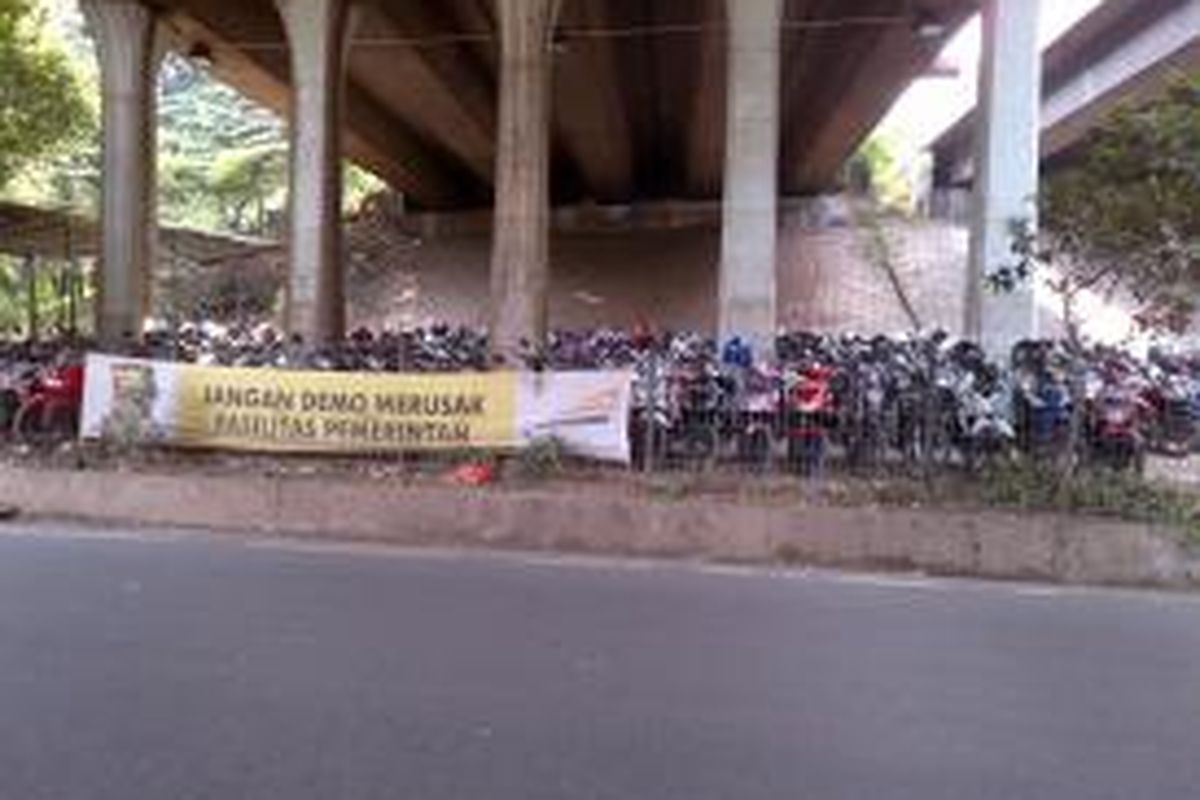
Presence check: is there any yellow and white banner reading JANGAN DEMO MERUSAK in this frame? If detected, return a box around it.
[80,355,632,463]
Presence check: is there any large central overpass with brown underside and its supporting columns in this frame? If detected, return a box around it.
[83,0,1038,351]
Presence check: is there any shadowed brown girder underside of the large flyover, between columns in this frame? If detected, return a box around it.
[157,0,978,210]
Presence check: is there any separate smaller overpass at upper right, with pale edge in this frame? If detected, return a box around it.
[931,0,1200,188]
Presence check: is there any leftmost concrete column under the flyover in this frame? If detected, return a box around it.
[82,0,160,345]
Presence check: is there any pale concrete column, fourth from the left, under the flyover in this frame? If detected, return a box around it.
[719,0,784,350]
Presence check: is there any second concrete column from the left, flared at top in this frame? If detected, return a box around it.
[275,0,352,343]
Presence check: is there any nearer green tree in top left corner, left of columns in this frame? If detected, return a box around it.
[0,0,95,188]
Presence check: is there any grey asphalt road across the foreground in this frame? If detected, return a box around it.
[0,529,1200,800]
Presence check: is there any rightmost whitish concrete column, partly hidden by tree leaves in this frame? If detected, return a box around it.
[966,0,1042,355]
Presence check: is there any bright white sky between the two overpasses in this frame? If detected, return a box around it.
[881,0,1103,150]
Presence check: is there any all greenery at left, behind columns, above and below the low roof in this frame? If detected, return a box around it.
[0,0,396,332]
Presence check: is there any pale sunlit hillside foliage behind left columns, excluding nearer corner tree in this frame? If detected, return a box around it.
[9,0,383,236]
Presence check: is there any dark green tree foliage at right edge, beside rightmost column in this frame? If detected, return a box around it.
[1014,80,1200,331]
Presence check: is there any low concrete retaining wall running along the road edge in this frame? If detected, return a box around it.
[0,467,1200,588]
